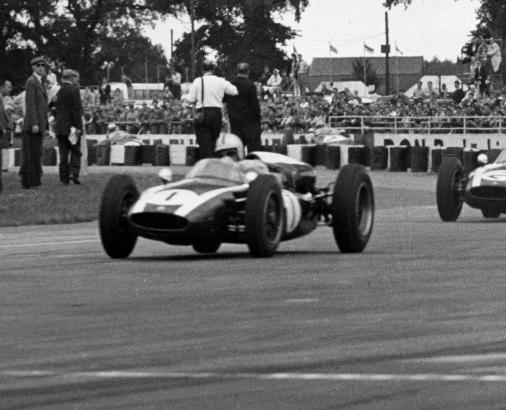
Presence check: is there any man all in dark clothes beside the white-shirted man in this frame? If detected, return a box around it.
[225,63,262,152]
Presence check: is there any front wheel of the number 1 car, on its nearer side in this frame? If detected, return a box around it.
[244,175,285,257]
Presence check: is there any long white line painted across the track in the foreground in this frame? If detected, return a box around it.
[0,370,506,383]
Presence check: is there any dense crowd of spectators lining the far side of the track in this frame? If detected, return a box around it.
[4,54,506,151]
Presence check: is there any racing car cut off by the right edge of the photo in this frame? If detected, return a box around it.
[436,149,506,222]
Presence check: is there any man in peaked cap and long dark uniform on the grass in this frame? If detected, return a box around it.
[19,57,48,188]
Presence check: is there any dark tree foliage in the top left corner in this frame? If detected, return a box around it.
[0,0,170,85]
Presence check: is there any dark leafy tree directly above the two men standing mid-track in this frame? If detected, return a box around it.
[169,0,308,77]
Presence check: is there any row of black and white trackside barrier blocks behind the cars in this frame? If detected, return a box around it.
[3,139,501,172]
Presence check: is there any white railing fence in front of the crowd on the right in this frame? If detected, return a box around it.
[328,116,506,135]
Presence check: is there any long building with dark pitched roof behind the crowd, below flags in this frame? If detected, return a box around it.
[308,56,423,94]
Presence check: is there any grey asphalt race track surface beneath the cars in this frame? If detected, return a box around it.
[0,170,506,409]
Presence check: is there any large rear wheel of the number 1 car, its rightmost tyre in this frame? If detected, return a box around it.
[331,164,374,253]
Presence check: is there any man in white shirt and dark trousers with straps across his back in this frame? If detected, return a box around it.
[187,61,238,158]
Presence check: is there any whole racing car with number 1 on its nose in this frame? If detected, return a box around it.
[99,152,375,258]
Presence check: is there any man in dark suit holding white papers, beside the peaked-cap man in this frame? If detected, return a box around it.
[55,70,83,185]
